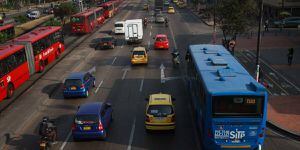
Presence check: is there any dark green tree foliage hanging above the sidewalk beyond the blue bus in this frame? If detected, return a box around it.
[216,0,258,39]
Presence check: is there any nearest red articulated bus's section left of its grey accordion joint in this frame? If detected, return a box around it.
[0,44,30,101]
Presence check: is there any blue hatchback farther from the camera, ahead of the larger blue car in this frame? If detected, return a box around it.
[63,72,95,98]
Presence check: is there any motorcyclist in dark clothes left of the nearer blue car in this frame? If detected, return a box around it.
[39,117,57,143]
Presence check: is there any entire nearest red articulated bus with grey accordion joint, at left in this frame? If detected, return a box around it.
[0,26,65,101]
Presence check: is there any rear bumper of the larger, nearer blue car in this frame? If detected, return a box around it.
[72,130,106,139]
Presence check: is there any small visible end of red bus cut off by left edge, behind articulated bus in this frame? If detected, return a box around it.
[0,23,15,43]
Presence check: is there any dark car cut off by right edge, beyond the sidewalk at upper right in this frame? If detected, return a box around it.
[273,17,300,28]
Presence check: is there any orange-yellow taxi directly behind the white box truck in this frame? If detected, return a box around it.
[131,47,148,65]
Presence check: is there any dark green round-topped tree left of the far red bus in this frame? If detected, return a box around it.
[54,2,78,25]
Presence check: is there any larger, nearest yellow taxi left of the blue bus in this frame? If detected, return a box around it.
[145,93,175,131]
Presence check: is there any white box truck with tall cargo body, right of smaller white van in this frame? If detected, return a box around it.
[125,19,143,44]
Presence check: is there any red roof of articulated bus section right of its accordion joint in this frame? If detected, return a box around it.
[13,26,61,43]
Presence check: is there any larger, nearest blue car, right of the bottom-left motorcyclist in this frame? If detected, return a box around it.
[72,102,113,140]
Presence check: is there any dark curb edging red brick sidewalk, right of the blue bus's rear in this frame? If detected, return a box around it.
[267,120,300,141]
